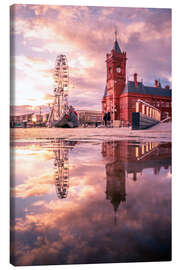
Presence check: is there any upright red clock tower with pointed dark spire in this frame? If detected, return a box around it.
[102,32,127,120]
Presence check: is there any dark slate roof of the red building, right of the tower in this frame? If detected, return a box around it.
[122,81,172,97]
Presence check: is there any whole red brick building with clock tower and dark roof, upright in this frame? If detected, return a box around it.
[102,34,172,126]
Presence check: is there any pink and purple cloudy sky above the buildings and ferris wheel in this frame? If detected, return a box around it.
[10,5,172,113]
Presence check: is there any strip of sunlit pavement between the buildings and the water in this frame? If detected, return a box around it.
[11,123,171,141]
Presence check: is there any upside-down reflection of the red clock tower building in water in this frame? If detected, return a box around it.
[102,141,171,220]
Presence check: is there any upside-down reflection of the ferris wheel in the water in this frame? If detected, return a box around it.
[53,139,76,199]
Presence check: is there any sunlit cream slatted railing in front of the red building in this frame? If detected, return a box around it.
[136,99,161,121]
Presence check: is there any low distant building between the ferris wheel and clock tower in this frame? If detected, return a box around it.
[77,110,101,125]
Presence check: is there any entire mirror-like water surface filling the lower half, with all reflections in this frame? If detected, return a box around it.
[11,140,171,265]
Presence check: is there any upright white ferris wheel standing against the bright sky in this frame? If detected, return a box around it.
[48,54,69,126]
